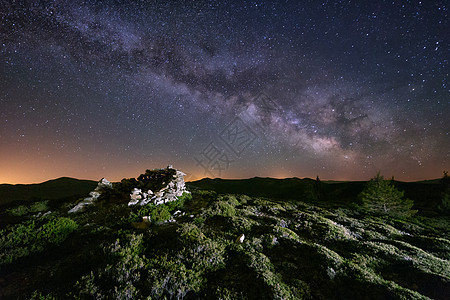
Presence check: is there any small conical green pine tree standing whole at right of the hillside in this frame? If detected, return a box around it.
[359,172,416,217]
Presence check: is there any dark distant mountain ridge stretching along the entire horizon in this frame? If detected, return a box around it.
[0,177,441,210]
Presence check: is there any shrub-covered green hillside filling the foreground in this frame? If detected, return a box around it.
[0,190,450,299]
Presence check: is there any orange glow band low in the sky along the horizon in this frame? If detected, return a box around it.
[0,154,441,184]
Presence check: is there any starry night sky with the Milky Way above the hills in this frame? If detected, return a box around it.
[0,0,450,183]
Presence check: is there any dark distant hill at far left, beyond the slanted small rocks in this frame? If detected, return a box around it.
[0,177,97,205]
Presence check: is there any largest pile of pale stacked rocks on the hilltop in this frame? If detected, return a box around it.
[128,165,187,206]
